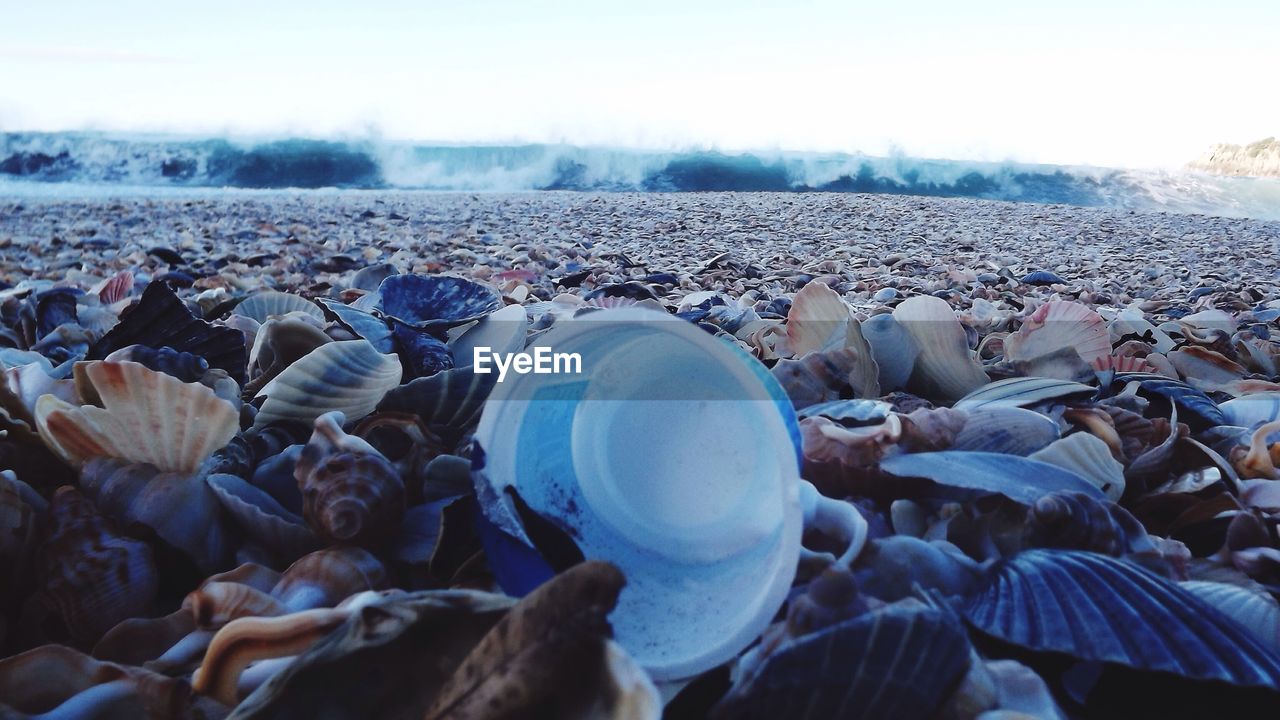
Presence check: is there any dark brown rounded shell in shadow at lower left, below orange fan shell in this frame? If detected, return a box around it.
[37,486,159,644]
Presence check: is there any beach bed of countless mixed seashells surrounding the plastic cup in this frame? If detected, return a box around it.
[0,196,1280,720]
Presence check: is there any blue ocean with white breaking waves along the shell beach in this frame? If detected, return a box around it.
[0,132,1280,220]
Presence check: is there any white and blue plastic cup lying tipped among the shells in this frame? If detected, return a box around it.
[476,309,803,680]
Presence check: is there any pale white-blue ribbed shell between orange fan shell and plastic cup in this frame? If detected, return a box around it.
[253,338,401,429]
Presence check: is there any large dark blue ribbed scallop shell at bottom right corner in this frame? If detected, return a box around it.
[964,550,1280,688]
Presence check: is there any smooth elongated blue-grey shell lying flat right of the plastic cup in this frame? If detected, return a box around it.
[879,451,1103,505]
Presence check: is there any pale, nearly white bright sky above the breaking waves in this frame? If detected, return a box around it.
[0,0,1280,168]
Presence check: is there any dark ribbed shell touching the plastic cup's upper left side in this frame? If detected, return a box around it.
[378,368,498,438]
